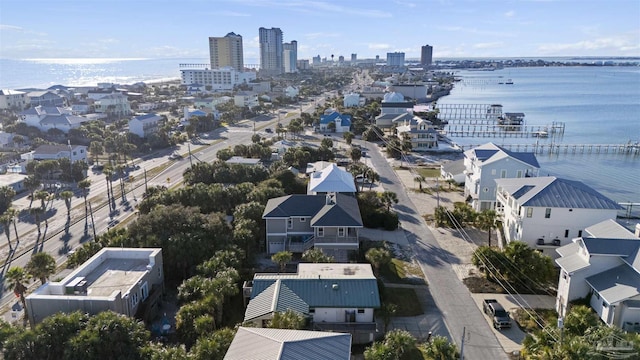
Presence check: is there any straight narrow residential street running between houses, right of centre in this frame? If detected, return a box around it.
[354,141,508,360]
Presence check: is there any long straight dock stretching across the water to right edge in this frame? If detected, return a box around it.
[457,142,640,156]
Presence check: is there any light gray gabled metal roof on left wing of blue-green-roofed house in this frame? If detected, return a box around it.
[244,279,309,321]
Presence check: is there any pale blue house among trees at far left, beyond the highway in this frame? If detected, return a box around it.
[20,105,89,134]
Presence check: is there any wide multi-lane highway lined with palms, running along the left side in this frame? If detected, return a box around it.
[0,99,314,312]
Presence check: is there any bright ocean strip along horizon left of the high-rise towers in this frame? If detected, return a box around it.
[0,58,209,89]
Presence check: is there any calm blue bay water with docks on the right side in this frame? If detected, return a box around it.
[438,67,640,221]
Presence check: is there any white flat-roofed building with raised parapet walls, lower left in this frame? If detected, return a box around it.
[25,247,164,324]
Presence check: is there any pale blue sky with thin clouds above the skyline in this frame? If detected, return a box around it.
[0,0,640,64]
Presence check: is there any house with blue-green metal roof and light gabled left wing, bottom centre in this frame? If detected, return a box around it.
[243,263,380,344]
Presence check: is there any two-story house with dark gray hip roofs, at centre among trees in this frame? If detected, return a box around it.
[262,193,363,261]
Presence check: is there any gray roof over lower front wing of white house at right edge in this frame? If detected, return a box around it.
[586,264,640,304]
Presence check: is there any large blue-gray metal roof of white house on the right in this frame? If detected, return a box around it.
[496,176,622,210]
